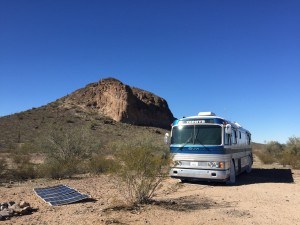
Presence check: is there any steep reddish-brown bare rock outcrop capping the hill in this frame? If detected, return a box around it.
[64,78,174,128]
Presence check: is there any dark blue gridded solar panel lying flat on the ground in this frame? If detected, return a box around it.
[33,184,90,206]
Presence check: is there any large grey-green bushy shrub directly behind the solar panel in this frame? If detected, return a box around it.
[39,126,99,178]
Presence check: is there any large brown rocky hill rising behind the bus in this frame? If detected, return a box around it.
[0,78,173,151]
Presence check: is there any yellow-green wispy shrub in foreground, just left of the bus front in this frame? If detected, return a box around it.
[115,144,170,205]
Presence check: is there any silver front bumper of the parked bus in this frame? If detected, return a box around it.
[170,168,230,181]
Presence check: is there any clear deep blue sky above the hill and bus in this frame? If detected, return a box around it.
[0,0,300,143]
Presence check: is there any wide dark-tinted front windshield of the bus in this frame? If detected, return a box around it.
[171,125,222,145]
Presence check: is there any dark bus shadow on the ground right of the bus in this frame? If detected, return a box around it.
[236,168,294,185]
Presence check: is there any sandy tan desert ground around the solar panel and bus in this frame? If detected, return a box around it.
[0,156,300,225]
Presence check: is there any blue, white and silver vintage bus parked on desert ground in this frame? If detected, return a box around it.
[165,112,253,183]
